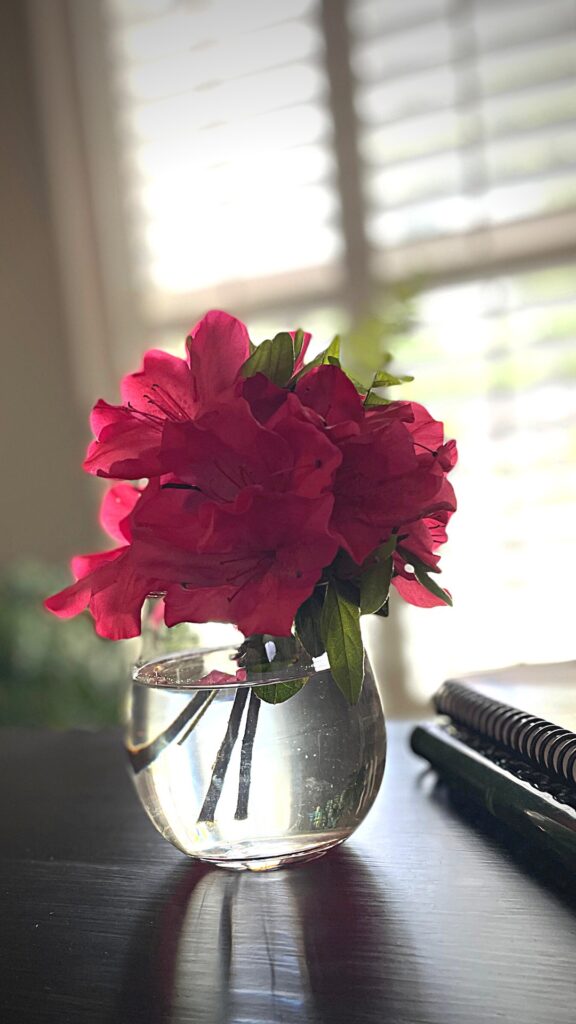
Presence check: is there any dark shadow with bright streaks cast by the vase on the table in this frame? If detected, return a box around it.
[115,850,419,1024]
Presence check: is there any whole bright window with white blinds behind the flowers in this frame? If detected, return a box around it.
[40,0,576,699]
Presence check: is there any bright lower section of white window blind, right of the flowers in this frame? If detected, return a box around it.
[391,263,576,694]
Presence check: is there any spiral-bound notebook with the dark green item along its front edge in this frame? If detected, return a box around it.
[411,662,576,866]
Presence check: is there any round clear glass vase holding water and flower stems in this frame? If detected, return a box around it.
[126,622,386,871]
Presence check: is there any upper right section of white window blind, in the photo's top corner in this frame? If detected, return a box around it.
[349,0,576,275]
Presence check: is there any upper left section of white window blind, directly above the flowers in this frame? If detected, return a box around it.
[104,0,341,321]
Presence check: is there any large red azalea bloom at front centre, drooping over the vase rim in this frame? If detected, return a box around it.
[130,487,337,636]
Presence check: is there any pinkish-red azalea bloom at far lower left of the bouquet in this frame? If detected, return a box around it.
[44,483,158,640]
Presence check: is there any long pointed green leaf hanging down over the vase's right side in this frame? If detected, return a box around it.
[322,583,364,705]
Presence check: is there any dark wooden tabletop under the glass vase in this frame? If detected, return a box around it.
[0,726,576,1024]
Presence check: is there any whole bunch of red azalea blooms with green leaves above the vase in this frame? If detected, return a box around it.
[46,311,456,700]
